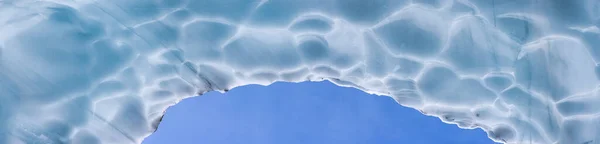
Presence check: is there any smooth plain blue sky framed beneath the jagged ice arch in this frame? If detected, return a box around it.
[143,82,493,144]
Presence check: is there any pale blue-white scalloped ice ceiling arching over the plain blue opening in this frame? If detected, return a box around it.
[0,0,600,144]
